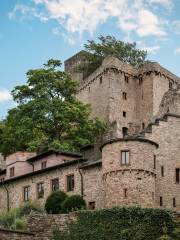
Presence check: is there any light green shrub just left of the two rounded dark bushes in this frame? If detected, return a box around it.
[19,202,43,217]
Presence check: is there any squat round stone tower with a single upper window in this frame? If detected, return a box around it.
[102,138,158,207]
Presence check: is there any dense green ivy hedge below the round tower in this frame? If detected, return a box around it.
[54,207,175,240]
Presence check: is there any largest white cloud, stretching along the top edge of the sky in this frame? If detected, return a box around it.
[9,0,172,38]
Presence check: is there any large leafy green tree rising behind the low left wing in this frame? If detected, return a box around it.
[0,59,105,155]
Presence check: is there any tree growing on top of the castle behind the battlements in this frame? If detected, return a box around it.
[77,35,147,76]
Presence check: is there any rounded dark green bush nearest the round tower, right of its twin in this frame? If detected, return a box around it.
[62,195,86,213]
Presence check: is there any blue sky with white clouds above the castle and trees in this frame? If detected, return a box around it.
[0,0,180,119]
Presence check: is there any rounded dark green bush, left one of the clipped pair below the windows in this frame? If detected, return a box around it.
[45,191,67,214]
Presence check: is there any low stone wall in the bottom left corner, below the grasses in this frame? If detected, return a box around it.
[0,228,33,240]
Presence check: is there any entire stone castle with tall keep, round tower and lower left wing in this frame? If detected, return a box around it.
[0,53,180,212]
